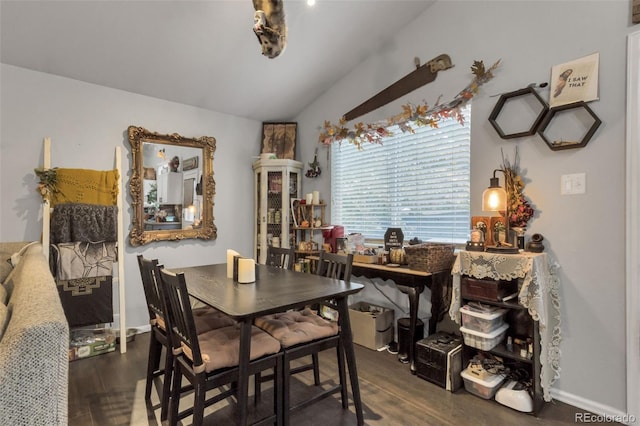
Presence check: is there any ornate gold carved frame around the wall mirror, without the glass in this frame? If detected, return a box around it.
[127,126,218,246]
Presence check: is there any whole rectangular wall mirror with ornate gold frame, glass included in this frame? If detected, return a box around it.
[128,126,217,246]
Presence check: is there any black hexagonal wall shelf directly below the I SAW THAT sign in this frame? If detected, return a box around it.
[538,102,602,151]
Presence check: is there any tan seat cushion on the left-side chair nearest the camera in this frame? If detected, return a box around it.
[183,325,280,372]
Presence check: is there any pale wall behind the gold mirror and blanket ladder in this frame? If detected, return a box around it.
[0,64,262,327]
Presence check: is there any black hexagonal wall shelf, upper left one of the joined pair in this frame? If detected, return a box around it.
[489,87,549,139]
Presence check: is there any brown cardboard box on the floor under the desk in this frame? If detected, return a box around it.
[349,302,394,350]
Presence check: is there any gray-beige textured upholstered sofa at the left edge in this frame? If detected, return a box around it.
[0,243,69,426]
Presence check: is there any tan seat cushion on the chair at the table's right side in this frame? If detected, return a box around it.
[255,309,339,348]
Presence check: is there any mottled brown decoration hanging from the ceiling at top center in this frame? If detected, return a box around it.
[253,0,287,59]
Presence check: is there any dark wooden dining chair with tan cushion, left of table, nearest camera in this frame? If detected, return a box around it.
[156,268,283,425]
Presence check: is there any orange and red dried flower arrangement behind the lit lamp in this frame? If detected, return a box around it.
[502,148,535,228]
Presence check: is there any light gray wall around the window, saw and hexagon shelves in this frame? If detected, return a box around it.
[296,0,638,420]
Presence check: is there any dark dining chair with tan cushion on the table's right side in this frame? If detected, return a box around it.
[255,252,353,424]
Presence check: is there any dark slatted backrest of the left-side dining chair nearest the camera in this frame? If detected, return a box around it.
[157,268,202,366]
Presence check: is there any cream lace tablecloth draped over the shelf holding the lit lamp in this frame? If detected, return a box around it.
[449,251,561,401]
